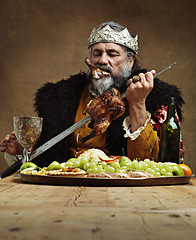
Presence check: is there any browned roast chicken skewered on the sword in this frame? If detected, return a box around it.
[80,88,125,143]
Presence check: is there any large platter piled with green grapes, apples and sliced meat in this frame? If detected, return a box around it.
[20,149,193,186]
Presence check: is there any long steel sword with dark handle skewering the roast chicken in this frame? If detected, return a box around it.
[1,62,176,178]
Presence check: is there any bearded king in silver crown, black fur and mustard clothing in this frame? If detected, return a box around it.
[1,22,184,167]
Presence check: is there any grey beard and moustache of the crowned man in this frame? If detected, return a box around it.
[87,63,132,96]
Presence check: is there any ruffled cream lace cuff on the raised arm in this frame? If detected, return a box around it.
[123,112,151,141]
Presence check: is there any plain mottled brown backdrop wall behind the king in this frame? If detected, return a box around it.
[0,0,196,173]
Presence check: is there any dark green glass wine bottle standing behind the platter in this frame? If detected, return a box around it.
[159,97,181,164]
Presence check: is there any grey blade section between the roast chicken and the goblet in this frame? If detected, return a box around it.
[29,115,92,161]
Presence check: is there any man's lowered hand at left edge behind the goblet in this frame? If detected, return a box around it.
[0,132,23,155]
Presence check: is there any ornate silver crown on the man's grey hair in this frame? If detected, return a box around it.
[88,25,139,54]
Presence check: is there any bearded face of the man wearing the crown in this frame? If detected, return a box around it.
[91,43,134,94]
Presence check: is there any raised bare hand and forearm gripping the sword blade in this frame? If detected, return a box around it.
[126,70,155,132]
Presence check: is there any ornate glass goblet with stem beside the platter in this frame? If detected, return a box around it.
[13,117,43,163]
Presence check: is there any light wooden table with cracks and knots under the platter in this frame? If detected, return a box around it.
[0,175,196,240]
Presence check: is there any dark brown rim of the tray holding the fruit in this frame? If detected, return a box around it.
[20,174,192,187]
